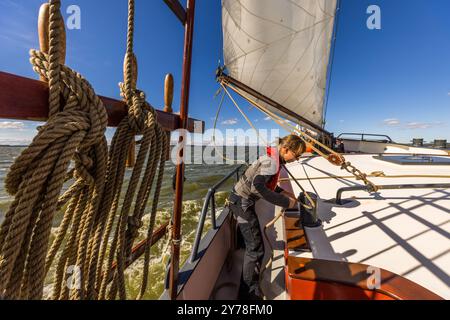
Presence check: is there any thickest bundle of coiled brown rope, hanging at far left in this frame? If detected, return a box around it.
[0,0,107,299]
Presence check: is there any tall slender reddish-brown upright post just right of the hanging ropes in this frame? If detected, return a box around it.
[169,0,195,300]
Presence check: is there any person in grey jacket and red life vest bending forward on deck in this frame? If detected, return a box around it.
[229,135,306,300]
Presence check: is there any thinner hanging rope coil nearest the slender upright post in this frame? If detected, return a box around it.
[98,0,169,299]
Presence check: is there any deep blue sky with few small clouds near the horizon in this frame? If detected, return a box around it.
[0,0,450,143]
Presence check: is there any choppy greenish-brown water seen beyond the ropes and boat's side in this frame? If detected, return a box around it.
[0,146,263,299]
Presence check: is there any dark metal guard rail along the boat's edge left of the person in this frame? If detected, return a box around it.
[190,164,244,263]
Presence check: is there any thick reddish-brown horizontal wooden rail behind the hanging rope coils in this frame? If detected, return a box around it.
[0,71,204,133]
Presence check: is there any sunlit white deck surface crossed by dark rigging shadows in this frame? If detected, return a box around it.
[278,155,450,299]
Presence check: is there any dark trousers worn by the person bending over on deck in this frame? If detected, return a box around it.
[230,194,264,296]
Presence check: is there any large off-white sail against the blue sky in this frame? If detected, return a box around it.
[222,0,337,126]
